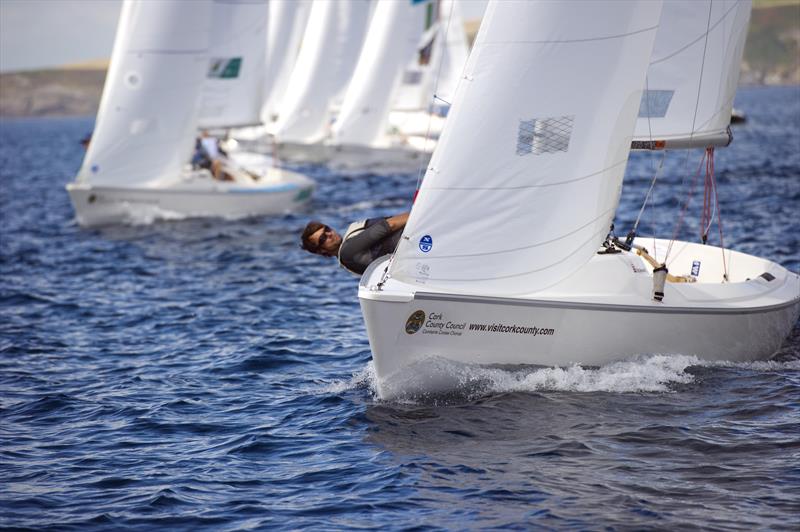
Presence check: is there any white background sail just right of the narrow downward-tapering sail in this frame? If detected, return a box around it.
[275,0,370,142]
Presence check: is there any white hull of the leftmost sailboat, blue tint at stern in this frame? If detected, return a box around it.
[67,164,315,227]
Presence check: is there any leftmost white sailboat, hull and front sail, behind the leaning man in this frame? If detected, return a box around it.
[67,0,314,226]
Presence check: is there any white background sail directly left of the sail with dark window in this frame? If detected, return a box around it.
[332,1,424,146]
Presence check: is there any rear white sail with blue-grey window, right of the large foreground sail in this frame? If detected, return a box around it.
[634,0,751,148]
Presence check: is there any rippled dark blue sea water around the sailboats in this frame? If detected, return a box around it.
[0,87,800,530]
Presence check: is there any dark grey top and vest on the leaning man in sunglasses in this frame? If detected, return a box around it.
[339,218,403,275]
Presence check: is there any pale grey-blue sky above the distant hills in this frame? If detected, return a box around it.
[0,0,487,72]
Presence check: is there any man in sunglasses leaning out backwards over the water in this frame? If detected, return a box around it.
[301,212,408,275]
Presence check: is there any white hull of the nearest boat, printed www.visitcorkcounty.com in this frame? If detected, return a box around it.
[359,240,800,399]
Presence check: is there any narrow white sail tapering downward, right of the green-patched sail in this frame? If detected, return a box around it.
[261,0,311,124]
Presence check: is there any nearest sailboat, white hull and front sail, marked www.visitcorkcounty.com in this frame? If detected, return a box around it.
[358,0,800,399]
